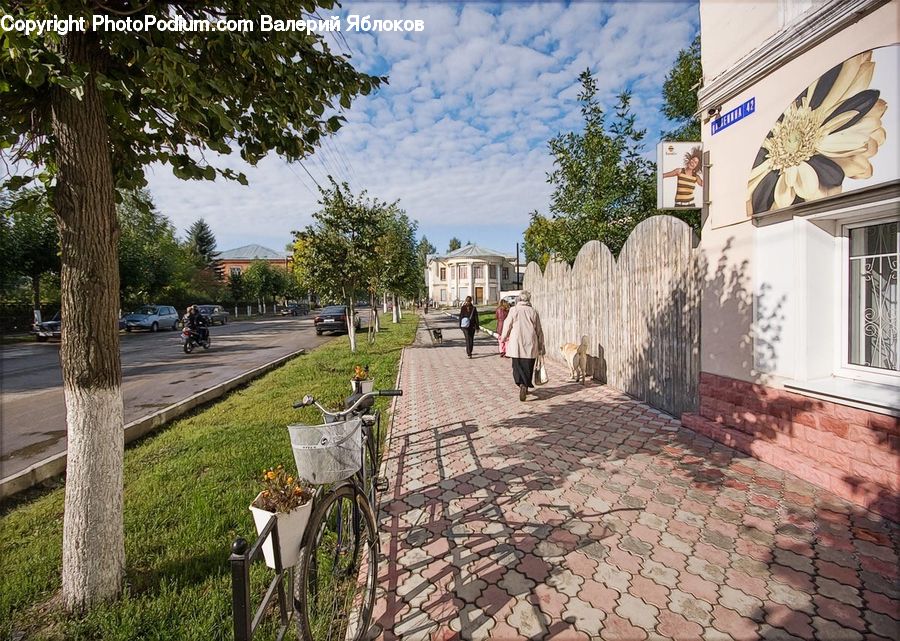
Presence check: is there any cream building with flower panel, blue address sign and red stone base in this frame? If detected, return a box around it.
[683,0,900,519]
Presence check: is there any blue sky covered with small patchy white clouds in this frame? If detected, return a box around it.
[147,0,699,255]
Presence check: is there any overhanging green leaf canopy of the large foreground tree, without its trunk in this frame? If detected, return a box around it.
[0,0,384,189]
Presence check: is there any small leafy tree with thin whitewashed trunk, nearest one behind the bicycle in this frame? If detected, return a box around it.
[294,180,382,352]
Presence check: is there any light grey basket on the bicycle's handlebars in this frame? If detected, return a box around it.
[288,417,362,485]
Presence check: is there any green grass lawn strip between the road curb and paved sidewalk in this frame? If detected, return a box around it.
[0,314,418,641]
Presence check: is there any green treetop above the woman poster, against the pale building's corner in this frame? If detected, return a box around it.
[662,34,703,142]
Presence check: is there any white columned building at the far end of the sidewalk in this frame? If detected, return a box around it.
[425,244,521,306]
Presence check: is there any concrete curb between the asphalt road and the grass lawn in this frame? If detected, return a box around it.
[0,349,306,501]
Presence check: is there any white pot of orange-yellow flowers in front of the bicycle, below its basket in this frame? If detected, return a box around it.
[250,465,313,569]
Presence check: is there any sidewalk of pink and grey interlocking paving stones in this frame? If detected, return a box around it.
[375,313,900,641]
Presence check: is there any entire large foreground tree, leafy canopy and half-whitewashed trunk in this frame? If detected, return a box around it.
[0,0,381,610]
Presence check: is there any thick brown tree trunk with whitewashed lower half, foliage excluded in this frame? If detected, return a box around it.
[52,32,125,610]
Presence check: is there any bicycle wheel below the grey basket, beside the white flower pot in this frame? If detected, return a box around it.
[294,484,378,641]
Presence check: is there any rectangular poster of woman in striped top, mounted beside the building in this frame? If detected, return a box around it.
[656,141,703,209]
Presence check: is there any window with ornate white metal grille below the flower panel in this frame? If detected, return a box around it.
[845,221,900,372]
